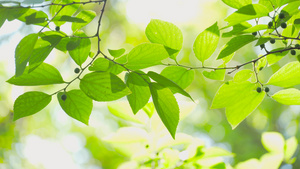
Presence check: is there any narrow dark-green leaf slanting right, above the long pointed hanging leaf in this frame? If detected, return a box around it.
[147,71,193,100]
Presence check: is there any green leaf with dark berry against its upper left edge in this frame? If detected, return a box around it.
[57,89,93,125]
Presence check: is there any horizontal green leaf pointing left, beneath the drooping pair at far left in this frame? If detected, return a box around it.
[7,63,65,86]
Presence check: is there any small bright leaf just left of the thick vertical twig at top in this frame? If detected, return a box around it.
[72,10,96,32]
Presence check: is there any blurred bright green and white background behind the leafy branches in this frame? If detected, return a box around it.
[0,0,300,169]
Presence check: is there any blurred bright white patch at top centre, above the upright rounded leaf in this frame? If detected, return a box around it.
[126,0,201,24]
